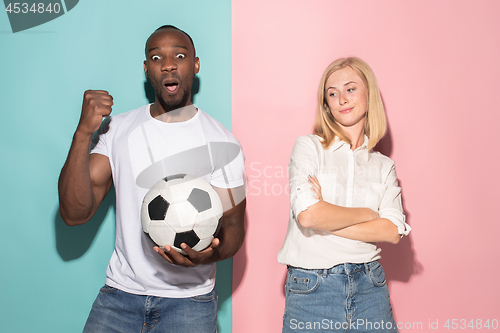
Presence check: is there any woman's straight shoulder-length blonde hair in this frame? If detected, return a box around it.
[314,57,387,149]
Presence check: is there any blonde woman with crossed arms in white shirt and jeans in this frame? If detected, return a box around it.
[278,57,410,333]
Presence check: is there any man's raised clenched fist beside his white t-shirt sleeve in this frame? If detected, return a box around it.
[76,90,113,135]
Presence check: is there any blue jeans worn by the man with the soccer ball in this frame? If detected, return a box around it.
[83,286,217,333]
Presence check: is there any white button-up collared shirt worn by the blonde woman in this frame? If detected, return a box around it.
[278,135,411,269]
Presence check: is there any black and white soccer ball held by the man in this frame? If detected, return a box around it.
[141,174,223,254]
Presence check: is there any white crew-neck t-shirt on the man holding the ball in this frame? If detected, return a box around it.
[91,105,245,298]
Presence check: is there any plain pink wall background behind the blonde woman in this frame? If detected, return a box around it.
[232,0,500,333]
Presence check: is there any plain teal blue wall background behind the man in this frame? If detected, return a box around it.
[0,0,232,333]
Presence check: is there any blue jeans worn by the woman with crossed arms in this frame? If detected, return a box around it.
[283,261,398,333]
